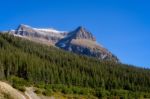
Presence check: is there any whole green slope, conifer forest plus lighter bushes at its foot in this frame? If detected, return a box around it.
[0,33,150,99]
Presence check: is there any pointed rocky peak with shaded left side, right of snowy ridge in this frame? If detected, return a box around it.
[56,27,119,62]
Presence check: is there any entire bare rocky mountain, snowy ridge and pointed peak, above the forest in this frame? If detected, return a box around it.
[9,25,119,62]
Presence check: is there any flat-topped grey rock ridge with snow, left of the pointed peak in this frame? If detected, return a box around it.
[12,24,66,44]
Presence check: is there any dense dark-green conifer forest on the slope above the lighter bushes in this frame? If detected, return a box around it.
[0,34,150,97]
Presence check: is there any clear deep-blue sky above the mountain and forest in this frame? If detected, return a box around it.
[0,0,150,68]
